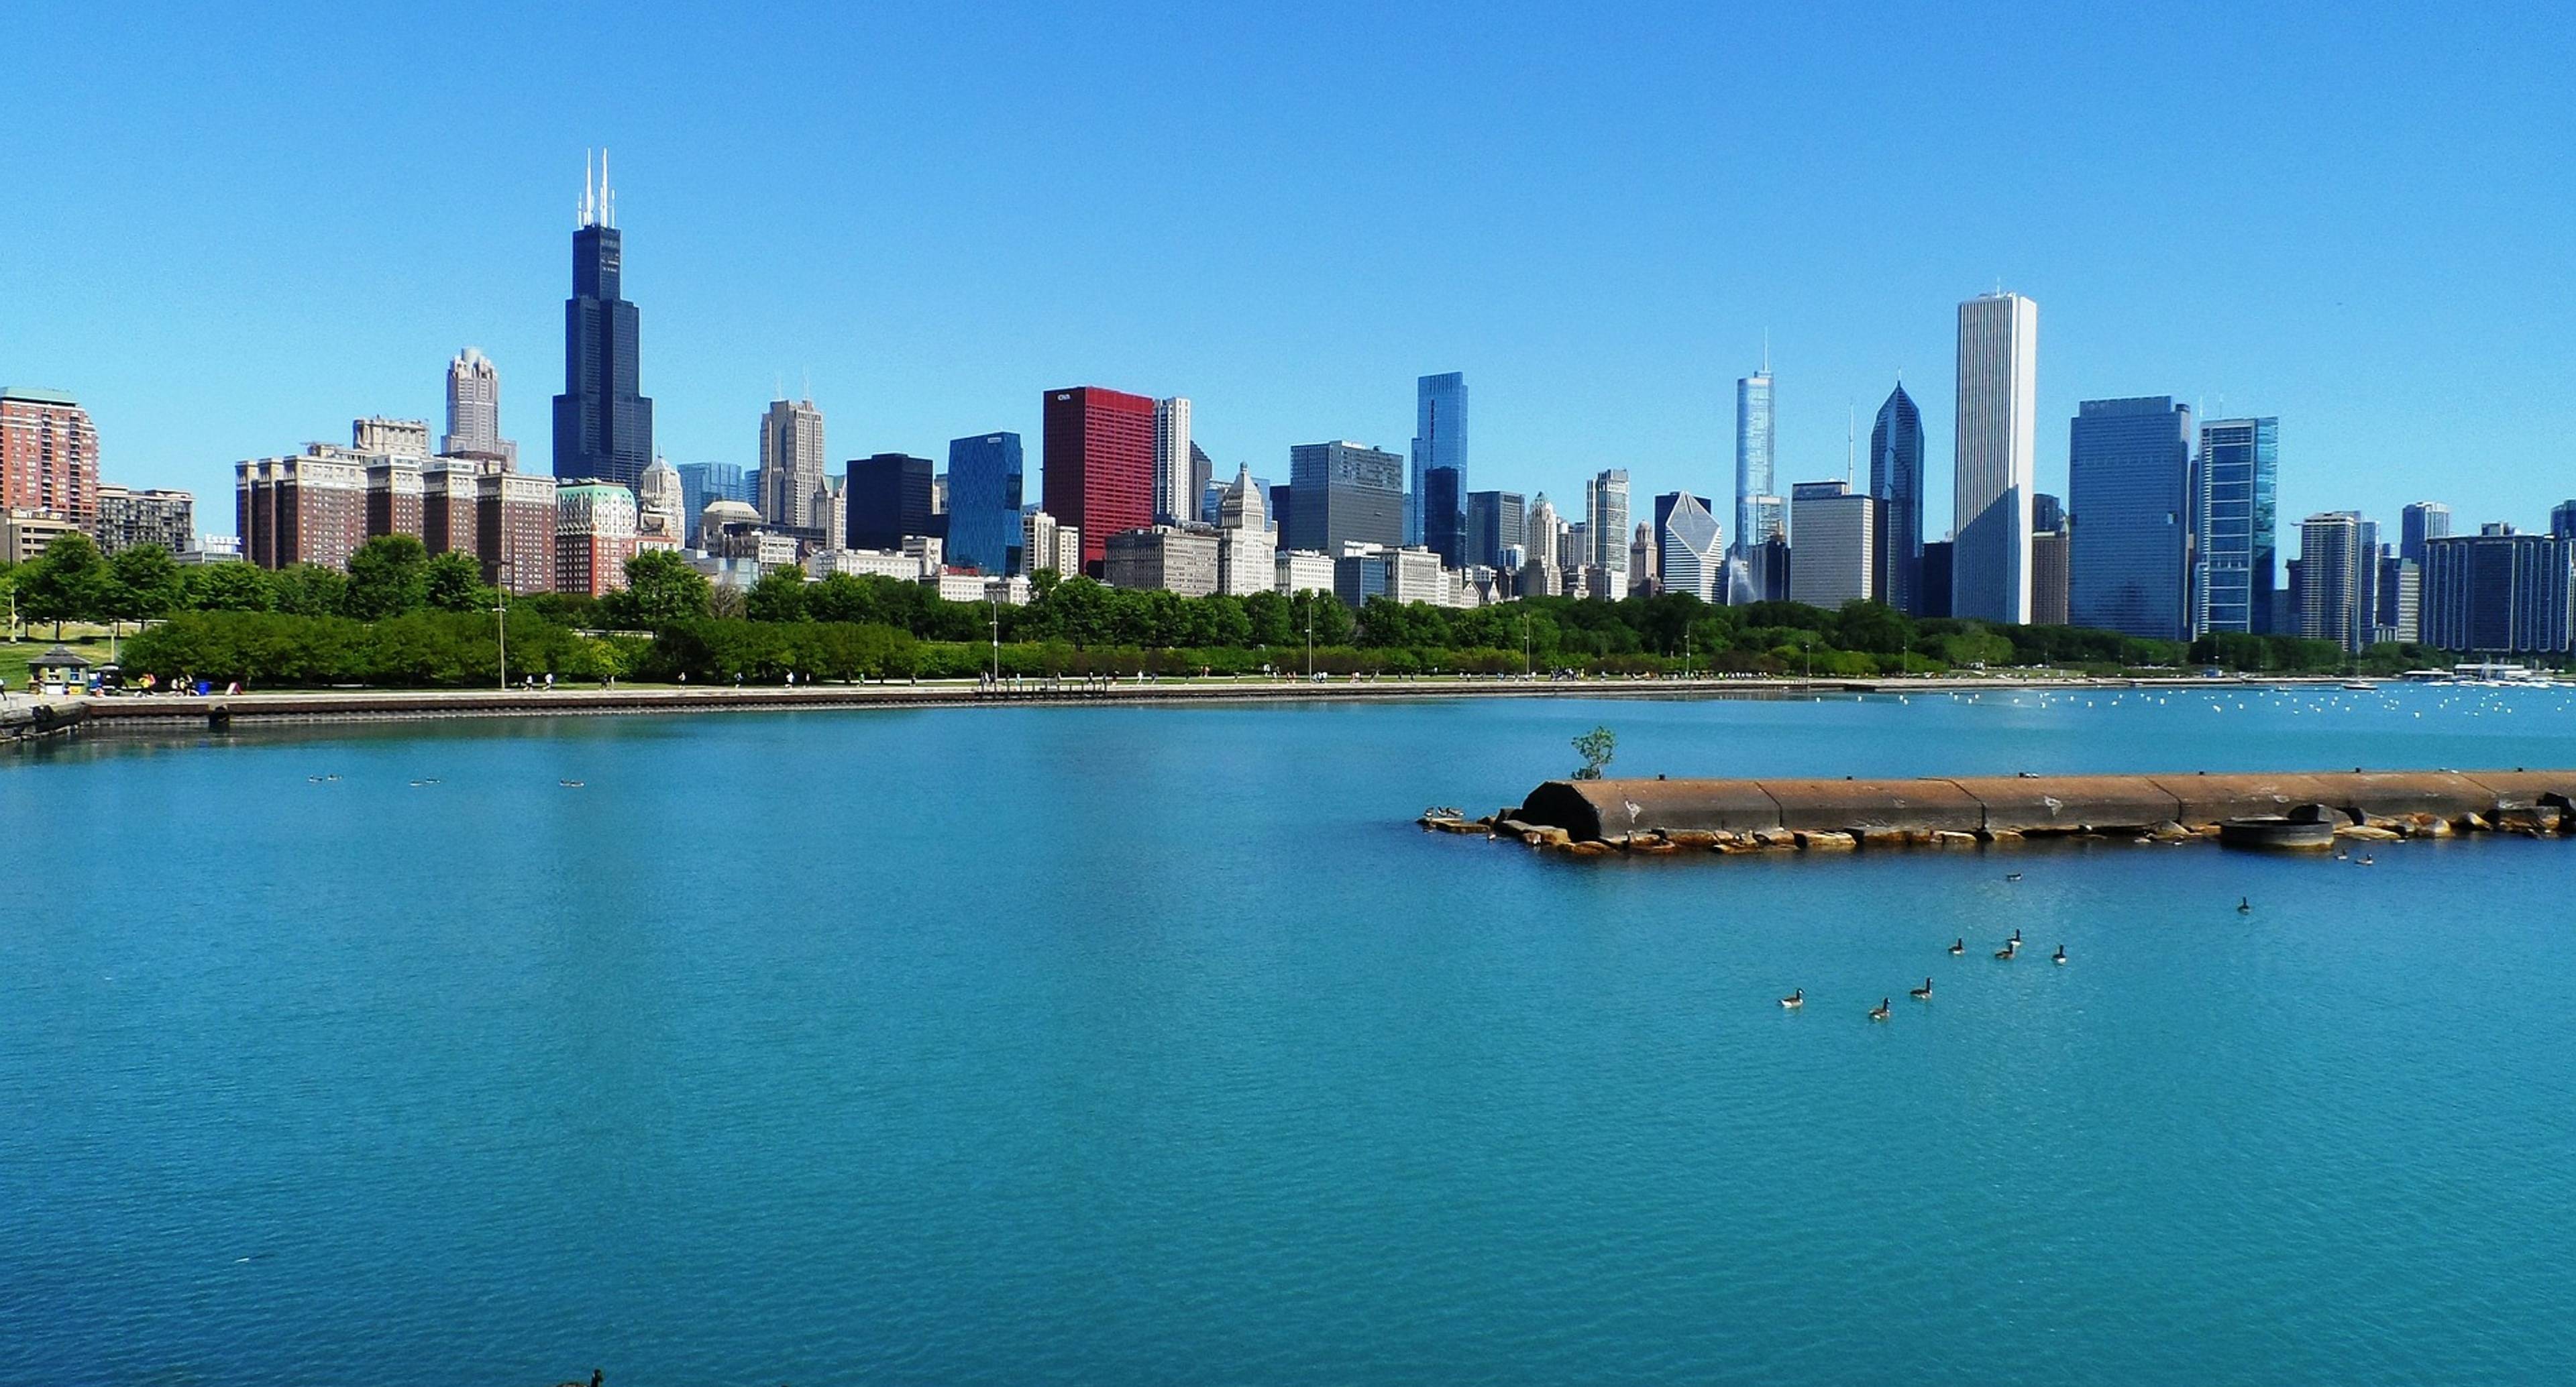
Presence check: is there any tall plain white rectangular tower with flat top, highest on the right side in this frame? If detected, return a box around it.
[1950,293,2040,622]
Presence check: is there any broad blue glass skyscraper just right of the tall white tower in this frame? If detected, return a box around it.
[2071,396,2192,641]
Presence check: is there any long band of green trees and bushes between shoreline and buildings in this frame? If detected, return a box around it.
[25,535,2437,685]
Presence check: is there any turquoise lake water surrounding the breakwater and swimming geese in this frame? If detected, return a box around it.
[0,689,2576,1387]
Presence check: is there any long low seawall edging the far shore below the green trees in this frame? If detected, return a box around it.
[10,677,2380,733]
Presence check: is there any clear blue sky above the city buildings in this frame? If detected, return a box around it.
[0,3,2576,548]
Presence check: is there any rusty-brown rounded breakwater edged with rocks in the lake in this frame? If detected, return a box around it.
[1422,769,2576,854]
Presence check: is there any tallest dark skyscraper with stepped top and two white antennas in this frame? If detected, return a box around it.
[546,152,652,488]
